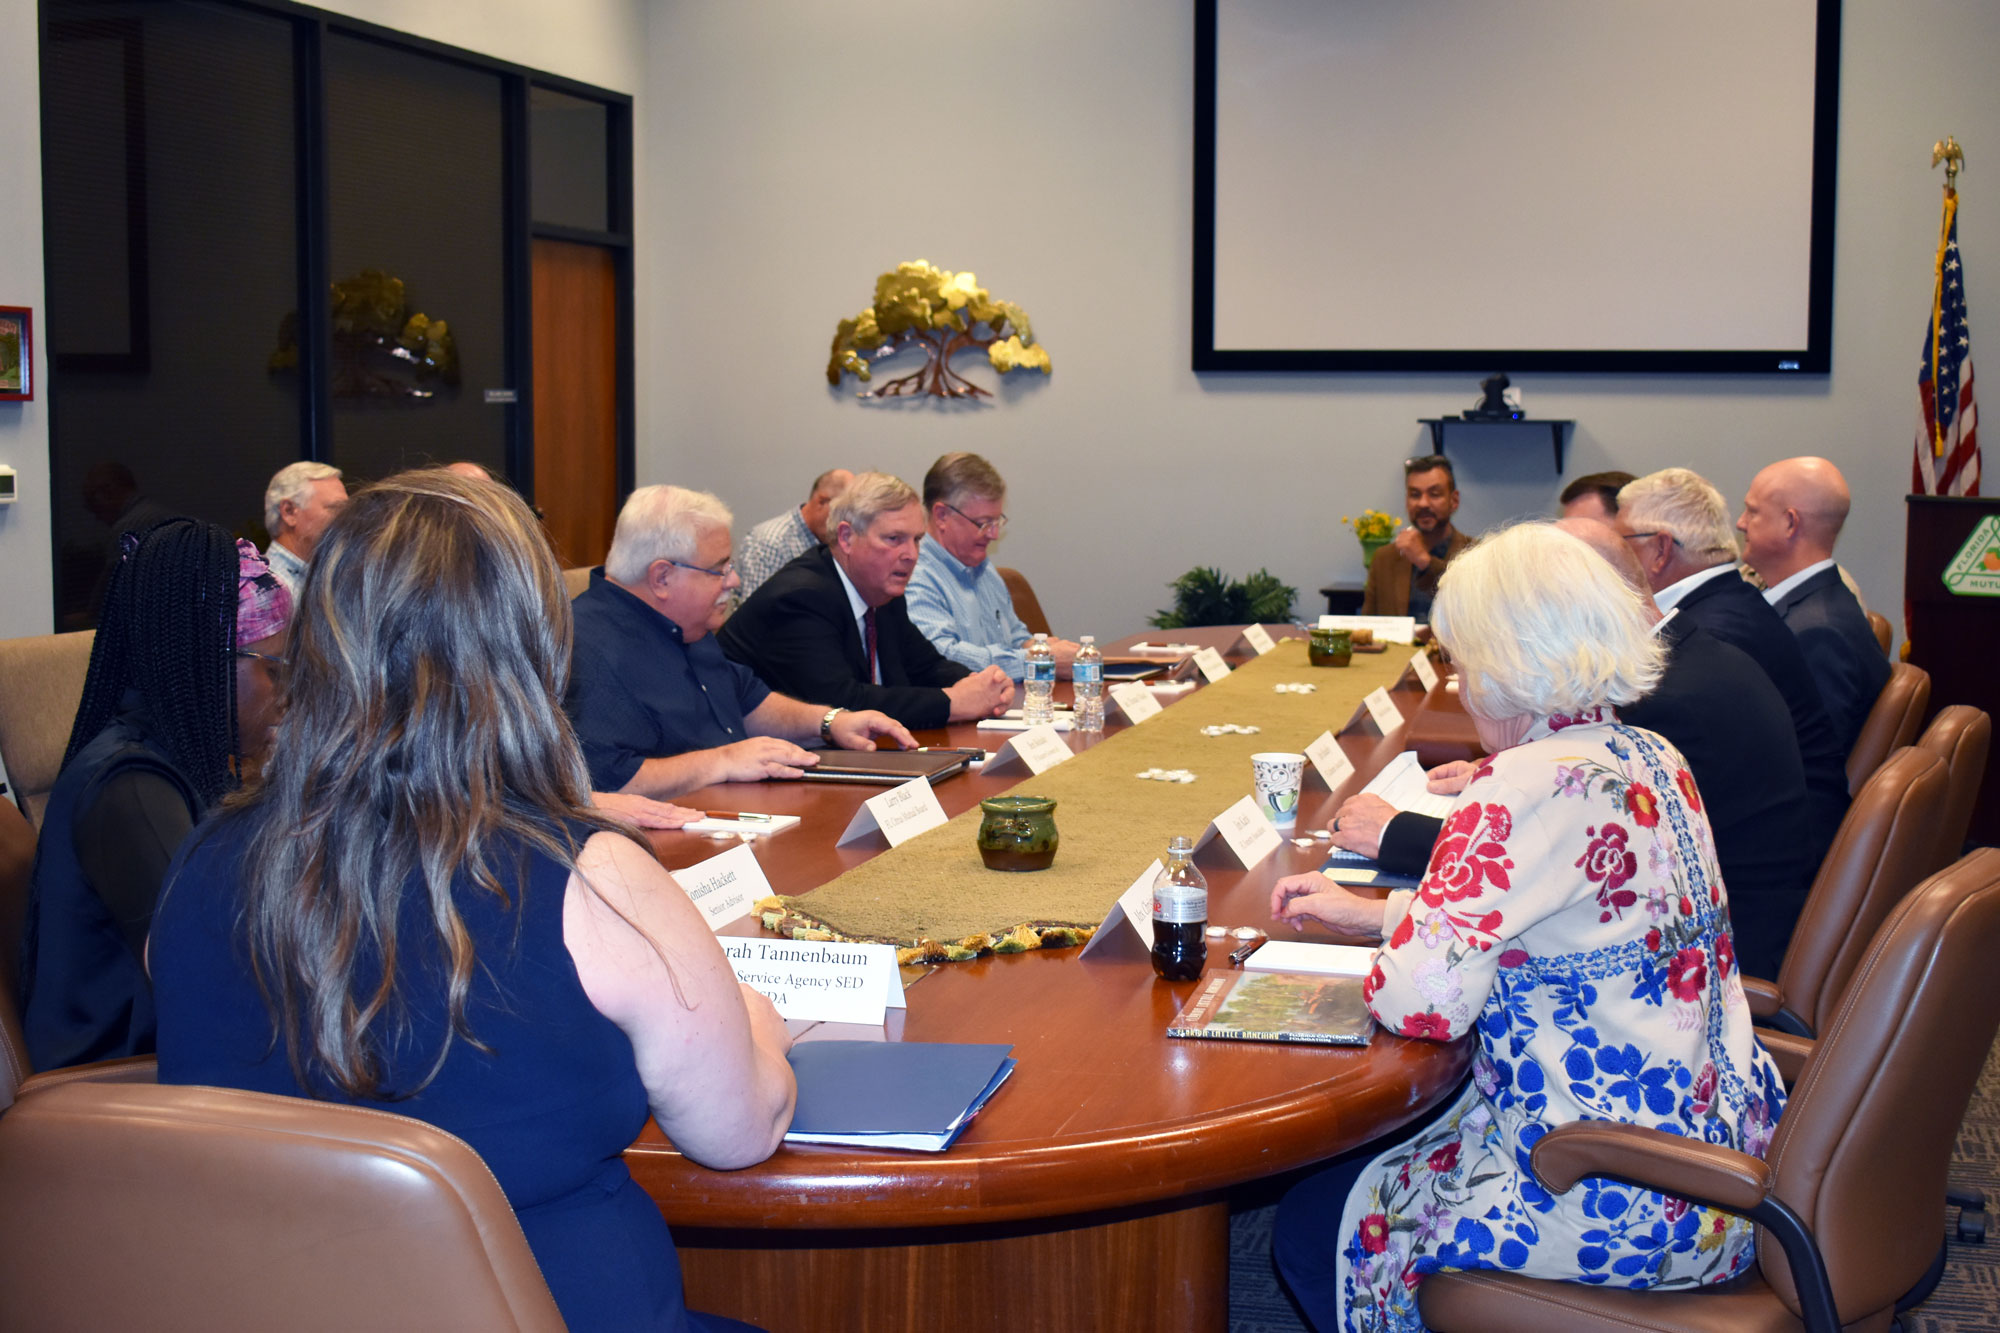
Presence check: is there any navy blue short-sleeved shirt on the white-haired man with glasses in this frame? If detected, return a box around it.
[564,568,770,791]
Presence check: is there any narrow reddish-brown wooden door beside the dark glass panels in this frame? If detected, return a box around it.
[534,238,618,568]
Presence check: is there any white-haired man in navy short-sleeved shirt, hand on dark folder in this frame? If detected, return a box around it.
[564,486,916,799]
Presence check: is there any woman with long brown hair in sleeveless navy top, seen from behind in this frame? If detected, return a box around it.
[150,470,794,1329]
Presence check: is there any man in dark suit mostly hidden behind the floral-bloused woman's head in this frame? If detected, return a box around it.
[1334,518,1824,977]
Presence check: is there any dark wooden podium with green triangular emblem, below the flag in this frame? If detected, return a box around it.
[1902,494,2000,851]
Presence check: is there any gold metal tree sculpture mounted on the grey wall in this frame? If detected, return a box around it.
[826,260,1048,398]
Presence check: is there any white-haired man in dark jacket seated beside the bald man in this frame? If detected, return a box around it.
[1612,468,1848,843]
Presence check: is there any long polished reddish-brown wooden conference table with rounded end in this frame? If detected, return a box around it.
[626,626,1472,1333]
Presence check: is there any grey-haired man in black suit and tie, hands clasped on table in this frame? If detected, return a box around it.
[716,472,1014,729]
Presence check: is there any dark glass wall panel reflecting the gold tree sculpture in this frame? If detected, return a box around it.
[324,32,514,478]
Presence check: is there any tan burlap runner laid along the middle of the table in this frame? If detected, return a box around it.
[786,638,1410,943]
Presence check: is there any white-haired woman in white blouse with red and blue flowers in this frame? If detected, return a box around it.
[1272,524,1784,1331]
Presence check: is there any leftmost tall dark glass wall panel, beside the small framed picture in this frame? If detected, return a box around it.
[42,0,300,628]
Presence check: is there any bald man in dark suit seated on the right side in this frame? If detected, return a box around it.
[1736,458,1890,755]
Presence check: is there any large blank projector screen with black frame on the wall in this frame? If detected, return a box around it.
[1192,0,1840,374]
